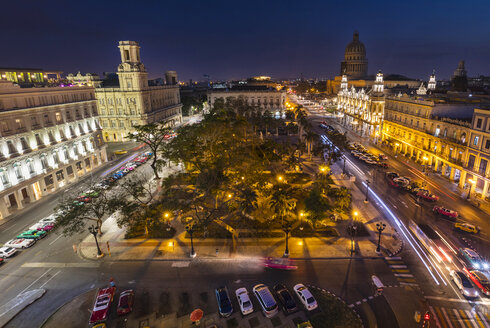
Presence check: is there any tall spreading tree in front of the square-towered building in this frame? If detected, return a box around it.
[127,123,171,180]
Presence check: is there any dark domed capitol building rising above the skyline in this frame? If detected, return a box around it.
[340,31,367,79]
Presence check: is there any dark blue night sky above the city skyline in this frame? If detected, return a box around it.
[0,0,490,80]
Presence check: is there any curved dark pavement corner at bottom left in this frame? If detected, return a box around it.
[41,288,97,328]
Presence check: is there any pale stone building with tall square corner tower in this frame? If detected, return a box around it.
[95,41,182,142]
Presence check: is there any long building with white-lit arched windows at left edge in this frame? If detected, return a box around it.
[0,81,107,219]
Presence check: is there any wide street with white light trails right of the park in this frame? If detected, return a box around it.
[298,96,490,327]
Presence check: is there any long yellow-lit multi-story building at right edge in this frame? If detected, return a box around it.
[382,95,490,198]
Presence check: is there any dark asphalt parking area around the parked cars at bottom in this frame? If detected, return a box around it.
[107,285,307,328]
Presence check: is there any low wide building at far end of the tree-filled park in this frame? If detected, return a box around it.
[208,86,286,117]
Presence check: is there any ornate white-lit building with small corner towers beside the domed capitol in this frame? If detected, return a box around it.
[337,72,385,140]
